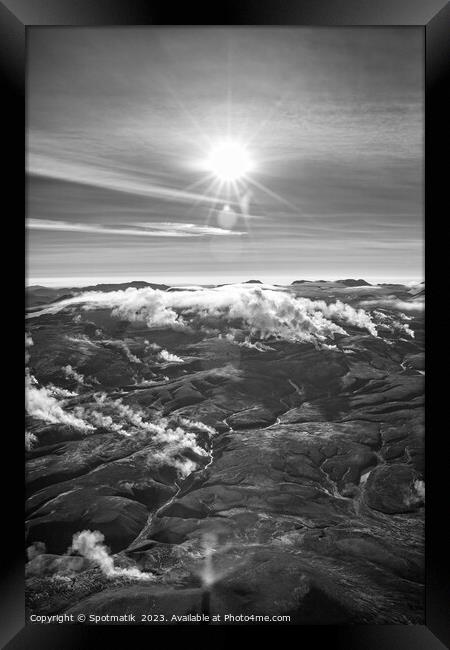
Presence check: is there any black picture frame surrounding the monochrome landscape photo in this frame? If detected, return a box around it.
[0,0,450,650]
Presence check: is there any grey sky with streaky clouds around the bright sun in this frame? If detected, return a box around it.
[26,27,424,286]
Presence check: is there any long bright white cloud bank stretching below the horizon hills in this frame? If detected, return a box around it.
[29,285,377,342]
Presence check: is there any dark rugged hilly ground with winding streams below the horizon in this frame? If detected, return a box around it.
[26,281,425,624]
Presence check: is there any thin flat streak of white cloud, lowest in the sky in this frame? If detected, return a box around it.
[27,218,245,237]
